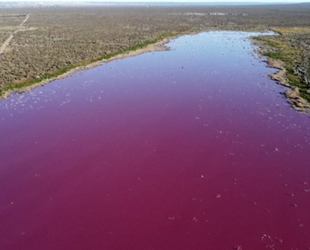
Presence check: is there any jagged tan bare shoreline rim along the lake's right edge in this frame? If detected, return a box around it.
[250,37,310,115]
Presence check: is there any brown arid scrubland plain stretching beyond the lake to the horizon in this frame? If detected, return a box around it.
[0,4,310,108]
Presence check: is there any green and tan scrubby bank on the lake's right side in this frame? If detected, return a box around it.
[253,27,310,114]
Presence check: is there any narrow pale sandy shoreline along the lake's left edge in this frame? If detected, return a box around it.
[0,34,173,100]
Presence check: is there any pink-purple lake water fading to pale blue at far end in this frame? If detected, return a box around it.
[0,32,310,250]
